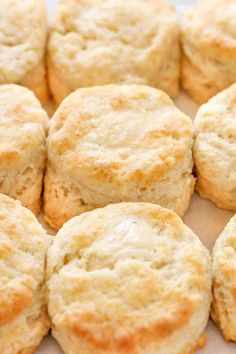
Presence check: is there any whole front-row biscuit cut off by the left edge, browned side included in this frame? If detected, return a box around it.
[0,194,50,354]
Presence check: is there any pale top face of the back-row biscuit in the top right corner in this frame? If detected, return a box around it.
[183,0,236,55]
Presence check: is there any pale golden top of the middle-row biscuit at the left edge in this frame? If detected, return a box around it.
[0,84,48,168]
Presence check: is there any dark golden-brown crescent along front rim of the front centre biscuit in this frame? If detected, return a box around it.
[57,297,195,354]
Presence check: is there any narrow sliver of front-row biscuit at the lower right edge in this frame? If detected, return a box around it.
[211,215,236,342]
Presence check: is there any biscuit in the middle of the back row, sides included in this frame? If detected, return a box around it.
[48,0,180,104]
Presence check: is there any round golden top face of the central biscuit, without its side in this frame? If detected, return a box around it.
[48,85,192,184]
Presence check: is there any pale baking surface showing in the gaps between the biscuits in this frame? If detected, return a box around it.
[35,0,236,354]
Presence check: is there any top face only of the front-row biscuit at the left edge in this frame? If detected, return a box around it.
[0,194,49,326]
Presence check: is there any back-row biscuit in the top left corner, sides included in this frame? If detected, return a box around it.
[0,0,48,104]
